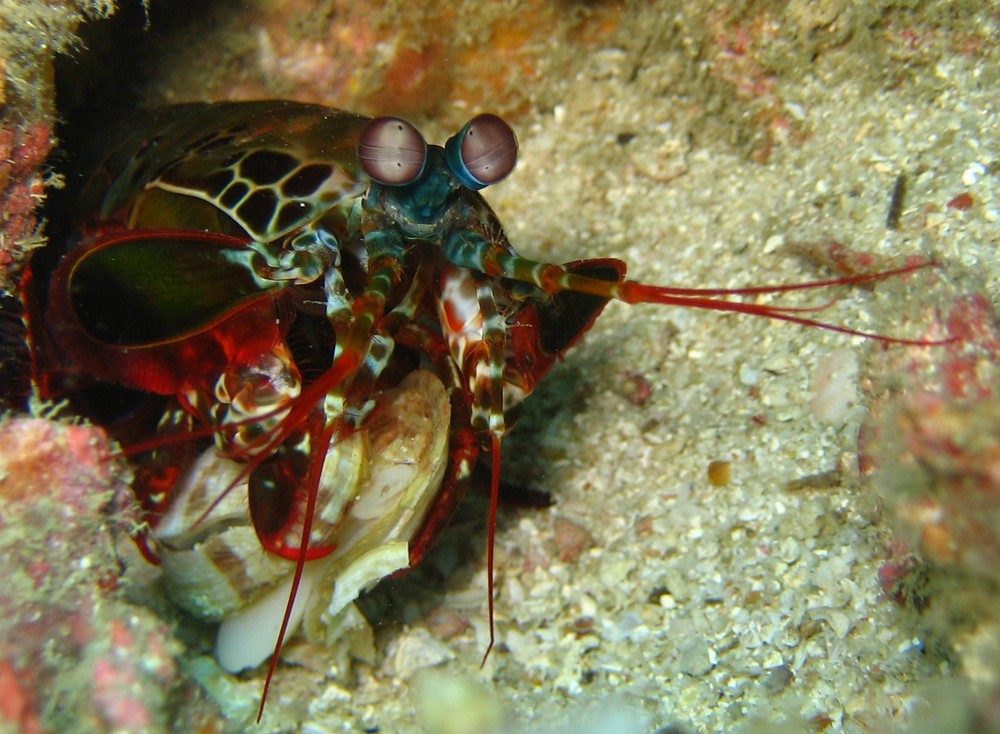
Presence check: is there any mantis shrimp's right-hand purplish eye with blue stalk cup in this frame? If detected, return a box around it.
[445,115,517,189]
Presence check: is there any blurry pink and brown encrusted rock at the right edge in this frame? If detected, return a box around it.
[862,264,1000,580]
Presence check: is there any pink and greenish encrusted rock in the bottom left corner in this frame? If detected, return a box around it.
[0,419,184,732]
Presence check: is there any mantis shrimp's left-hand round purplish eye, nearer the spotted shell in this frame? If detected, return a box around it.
[358,117,427,186]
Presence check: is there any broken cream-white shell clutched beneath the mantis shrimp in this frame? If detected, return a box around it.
[156,370,451,672]
